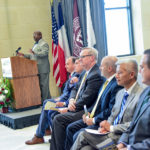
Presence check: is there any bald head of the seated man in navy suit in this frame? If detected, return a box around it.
[100,56,118,78]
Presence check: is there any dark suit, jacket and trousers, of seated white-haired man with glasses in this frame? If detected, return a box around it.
[50,65,105,150]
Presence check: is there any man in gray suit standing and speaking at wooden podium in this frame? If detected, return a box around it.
[18,31,51,102]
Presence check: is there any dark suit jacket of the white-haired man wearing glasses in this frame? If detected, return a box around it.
[70,64,105,112]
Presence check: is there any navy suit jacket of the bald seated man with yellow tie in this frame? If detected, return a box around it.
[89,77,123,125]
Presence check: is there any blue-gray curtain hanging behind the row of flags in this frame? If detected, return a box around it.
[51,0,107,63]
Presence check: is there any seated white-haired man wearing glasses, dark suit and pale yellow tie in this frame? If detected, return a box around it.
[50,48,105,150]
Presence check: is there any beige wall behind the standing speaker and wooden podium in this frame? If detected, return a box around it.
[0,0,59,97]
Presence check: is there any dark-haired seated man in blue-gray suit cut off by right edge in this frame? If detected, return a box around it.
[117,49,150,150]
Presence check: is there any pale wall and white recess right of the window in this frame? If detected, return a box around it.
[131,0,150,54]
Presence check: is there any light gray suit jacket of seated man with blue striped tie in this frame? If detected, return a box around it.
[108,83,143,139]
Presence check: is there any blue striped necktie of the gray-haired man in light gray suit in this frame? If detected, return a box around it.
[114,92,129,125]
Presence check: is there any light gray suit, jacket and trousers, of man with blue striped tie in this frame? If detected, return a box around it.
[70,83,143,149]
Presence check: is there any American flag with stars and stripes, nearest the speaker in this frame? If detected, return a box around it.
[51,5,67,87]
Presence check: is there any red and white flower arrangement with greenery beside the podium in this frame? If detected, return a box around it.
[0,78,13,113]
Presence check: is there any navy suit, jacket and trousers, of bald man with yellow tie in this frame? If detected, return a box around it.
[65,77,123,150]
